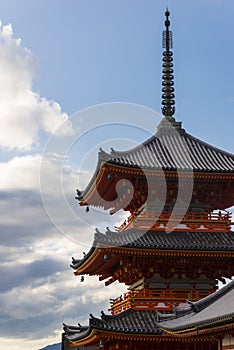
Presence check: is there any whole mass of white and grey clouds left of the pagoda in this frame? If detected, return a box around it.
[0,19,126,350]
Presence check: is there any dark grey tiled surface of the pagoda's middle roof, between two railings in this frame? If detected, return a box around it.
[71,229,234,269]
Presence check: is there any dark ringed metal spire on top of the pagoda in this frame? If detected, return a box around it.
[162,9,175,117]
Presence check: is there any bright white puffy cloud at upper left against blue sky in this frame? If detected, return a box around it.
[0,24,72,150]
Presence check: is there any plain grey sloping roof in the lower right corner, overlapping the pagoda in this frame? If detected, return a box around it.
[160,281,234,332]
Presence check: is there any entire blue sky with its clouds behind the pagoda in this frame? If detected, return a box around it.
[0,0,234,350]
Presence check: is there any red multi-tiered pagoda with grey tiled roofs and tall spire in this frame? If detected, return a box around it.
[63,10,234,350]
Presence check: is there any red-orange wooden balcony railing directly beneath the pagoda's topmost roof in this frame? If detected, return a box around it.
[118,210,231,232]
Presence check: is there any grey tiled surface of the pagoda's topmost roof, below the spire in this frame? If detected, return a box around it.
[99,128,234,173]
